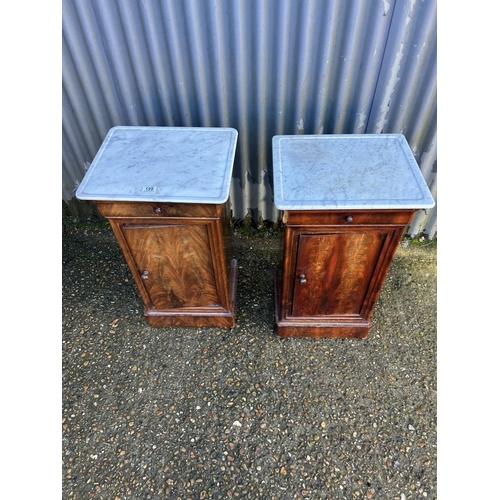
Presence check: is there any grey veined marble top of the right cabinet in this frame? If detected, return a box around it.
[273,134,434,210]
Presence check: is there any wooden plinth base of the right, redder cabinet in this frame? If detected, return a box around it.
[274,273,372,339]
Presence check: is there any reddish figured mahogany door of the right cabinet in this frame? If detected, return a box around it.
[291,231,387,317]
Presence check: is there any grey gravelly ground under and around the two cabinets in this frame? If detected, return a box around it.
[62,217,437,500]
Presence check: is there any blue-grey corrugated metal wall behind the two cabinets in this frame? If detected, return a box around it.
[62,0,437,237]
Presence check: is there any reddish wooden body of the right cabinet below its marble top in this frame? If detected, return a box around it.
[275,210,414,338]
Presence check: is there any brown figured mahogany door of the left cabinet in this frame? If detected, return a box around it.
[122,224,220,309]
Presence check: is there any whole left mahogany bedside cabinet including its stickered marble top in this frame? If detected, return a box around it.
[76,127,238,327]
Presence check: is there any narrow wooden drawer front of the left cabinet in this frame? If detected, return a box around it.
[95,201,221,218]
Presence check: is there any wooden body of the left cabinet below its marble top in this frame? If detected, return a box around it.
[96,202,237,327]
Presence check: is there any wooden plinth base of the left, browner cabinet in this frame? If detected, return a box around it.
[144,259,238,328]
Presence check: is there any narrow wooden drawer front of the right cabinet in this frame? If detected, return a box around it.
[283,210,415,227]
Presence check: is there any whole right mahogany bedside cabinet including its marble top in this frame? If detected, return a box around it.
[272,134,434,338]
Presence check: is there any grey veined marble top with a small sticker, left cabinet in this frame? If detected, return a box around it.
[76,127,238,204]
